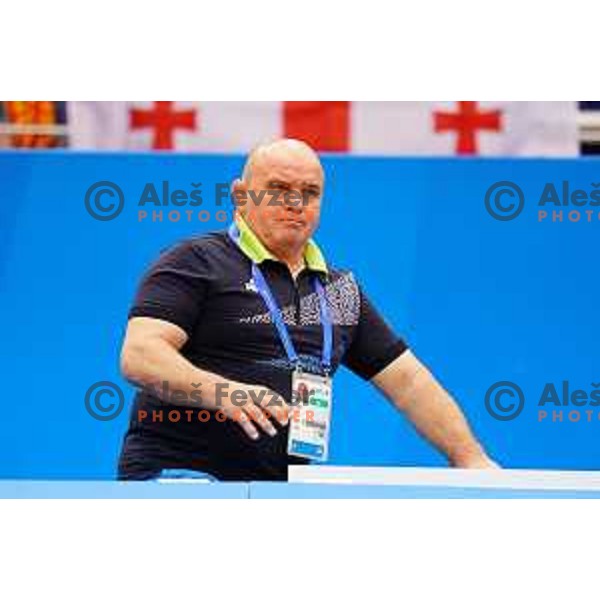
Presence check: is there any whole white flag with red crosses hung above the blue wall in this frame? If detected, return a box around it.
[68,101,578,156]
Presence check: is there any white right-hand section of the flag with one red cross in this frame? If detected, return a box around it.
[352,101,579,156]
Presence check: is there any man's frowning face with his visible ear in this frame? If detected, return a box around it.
[234,152,323,250]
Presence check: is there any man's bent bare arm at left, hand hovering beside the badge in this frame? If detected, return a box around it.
[121,317,288,439]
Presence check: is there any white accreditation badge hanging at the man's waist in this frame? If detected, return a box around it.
[287,369,332,461]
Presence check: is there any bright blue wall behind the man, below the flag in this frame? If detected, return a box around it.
[0,152,600,478]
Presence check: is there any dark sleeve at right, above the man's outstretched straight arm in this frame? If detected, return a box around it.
[342,288,408,380]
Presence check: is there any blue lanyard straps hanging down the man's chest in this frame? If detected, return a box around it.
[252,263,333,375]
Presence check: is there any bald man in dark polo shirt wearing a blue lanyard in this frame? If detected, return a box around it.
[119,140,496,480]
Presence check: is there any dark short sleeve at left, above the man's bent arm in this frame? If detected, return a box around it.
[129,242,210,336]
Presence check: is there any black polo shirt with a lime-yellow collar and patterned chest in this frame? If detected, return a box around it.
[118,220,406,481]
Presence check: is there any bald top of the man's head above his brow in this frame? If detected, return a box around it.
[242,138,324,184]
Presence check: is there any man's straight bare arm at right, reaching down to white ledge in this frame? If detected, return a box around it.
[371,350,497,469]
